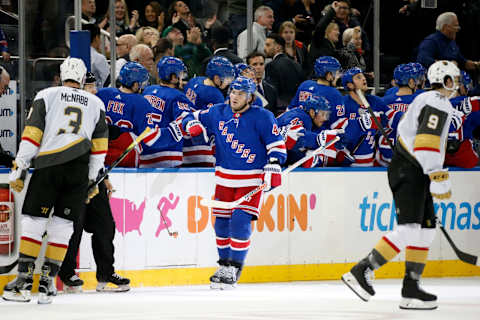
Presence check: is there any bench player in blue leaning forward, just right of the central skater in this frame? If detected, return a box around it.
[277,95,343,168]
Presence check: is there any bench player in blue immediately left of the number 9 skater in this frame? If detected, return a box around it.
[375,64,417,167]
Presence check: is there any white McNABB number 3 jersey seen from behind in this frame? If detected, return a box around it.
[17,86,108,179]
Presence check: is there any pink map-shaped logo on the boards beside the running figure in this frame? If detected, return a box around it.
[110,197,146,235]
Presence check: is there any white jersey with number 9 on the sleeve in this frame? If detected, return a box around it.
[397,90,454,174]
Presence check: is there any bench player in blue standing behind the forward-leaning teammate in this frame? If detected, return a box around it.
[288,56,346,129]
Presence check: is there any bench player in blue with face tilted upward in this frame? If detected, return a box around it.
[342,68,388,167]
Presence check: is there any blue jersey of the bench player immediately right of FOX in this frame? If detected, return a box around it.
[140,85,194,167]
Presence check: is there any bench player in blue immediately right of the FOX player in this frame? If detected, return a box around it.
[140,56,204,167]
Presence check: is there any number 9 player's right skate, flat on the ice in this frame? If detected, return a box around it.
[400,277,438,310]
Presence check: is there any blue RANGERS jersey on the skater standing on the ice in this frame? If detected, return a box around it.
[195,103,287,188]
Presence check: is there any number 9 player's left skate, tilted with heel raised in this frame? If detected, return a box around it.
[342,260,375,301]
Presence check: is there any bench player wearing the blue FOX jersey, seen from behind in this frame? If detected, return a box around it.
[97,62,181,167]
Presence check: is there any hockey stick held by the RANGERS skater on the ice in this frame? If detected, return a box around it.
[200,137,340,209]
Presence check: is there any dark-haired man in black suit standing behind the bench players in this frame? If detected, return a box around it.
[264,34,304,110]
